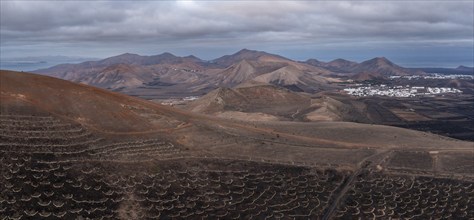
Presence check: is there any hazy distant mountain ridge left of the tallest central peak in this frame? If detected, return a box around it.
[34,53,207,93]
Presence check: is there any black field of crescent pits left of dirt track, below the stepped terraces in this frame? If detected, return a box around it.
[0,150,345,219]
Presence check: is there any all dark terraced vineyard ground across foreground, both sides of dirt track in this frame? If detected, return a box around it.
[0,114,474,219]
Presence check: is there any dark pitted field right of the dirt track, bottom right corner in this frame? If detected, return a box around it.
[335,173,474,219]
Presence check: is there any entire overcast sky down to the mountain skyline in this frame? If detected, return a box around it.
[0,0,474,67]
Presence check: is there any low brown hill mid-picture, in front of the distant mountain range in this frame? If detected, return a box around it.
[183,81,371,123]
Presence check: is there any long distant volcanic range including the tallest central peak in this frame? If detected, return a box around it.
[35,49,331,96]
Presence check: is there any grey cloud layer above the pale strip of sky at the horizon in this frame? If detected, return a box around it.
[0,1,474,64]
